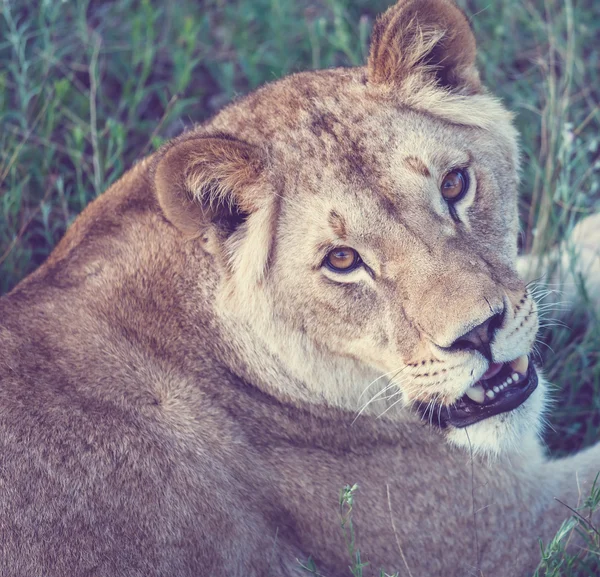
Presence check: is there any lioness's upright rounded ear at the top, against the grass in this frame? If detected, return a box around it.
[368,0,482,94]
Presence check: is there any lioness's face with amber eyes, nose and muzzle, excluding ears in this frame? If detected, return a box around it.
[267,99,538,454]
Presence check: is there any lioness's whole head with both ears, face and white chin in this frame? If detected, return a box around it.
[156,0,543,452]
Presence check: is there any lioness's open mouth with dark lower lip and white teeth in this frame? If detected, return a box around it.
[419,356,538,428]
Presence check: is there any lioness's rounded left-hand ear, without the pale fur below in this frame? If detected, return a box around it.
[154,137,265,236]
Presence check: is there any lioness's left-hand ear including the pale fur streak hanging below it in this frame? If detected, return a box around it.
[153,135,274,284]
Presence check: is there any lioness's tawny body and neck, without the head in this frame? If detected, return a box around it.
[0,222,577,577]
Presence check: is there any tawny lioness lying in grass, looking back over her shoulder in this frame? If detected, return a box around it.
[0,0,600,577]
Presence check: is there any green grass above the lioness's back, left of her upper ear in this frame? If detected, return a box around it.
[0,0,385,293]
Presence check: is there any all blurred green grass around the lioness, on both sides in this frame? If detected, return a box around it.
[0,0,600,575]
